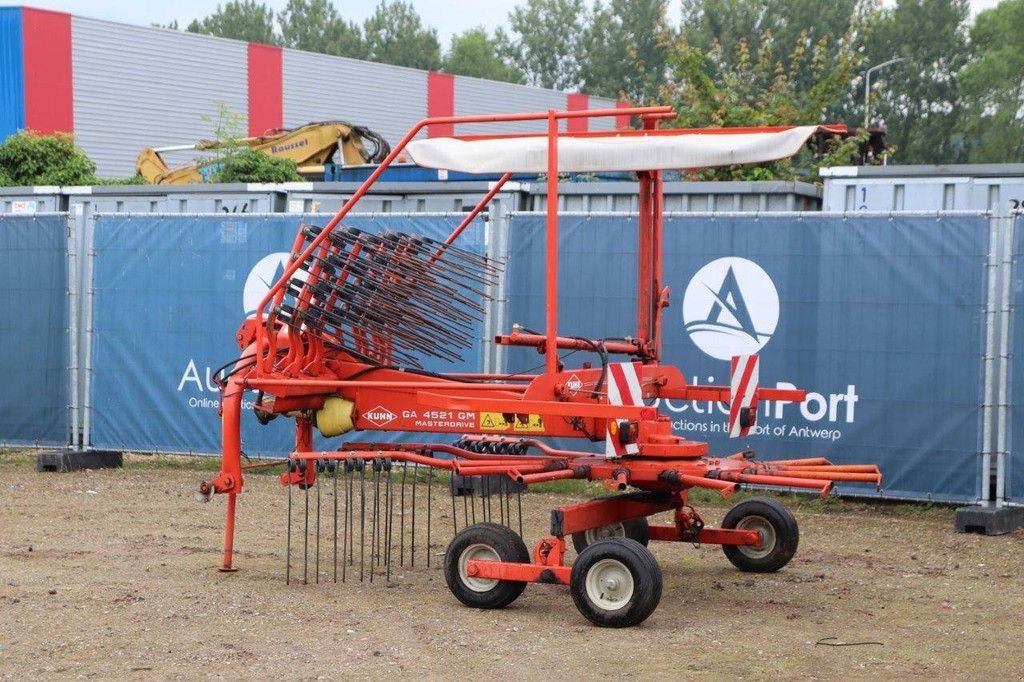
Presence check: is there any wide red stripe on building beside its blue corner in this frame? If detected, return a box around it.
[22,7,75,133]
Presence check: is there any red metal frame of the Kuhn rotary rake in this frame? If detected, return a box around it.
[201,106,881,582]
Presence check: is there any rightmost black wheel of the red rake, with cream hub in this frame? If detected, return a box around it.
[722,491,800,573]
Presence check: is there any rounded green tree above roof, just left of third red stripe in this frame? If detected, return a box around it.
[362,0,441,70]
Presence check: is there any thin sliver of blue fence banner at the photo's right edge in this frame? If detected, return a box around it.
[1006,215,1024,503]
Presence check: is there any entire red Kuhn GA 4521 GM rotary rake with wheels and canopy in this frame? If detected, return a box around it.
[201,108,881,627]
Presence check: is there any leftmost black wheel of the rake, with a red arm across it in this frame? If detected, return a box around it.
[444,523,530,608]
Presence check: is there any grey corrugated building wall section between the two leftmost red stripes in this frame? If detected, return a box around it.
[72,16,248,176]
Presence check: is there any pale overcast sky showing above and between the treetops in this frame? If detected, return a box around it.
[0,0,998,48]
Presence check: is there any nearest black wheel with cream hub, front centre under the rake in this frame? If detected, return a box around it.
[569,538,662,628]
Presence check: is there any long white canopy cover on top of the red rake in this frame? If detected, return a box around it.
[407,126,819,173]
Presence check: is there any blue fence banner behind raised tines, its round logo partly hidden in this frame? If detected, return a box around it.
[91,214,483,456]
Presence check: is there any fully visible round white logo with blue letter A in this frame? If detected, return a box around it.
[683,257,779,360]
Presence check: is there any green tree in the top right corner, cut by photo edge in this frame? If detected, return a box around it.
[958,0,1024,163]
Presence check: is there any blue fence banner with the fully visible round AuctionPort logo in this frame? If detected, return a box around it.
[505,214,991,501]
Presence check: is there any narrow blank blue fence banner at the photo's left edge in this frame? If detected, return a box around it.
[0,214,71,445]
